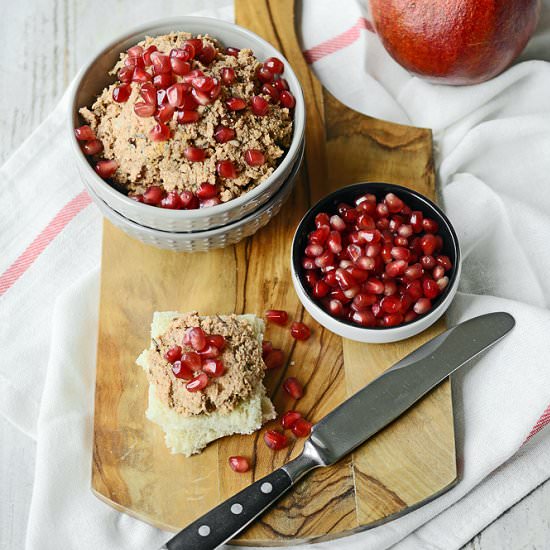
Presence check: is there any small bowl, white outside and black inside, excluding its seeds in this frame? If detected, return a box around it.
[290,182,461,344]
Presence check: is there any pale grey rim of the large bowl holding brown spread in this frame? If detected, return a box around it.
[66,15,306,221]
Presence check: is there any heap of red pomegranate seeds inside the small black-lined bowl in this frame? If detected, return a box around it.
[302,193,453,327]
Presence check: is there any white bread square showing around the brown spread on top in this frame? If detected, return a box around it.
[136,311,277,456]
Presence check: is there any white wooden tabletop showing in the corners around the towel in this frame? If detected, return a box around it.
[0,0,550,550]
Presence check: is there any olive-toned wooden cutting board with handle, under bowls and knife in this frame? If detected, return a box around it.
[92,0,457,545]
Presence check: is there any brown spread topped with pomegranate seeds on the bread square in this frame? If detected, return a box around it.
[146,312,265,416]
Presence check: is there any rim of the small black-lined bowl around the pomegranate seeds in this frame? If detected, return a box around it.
[291,181,462,334]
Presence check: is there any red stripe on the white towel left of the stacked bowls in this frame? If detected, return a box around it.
[0,191,92,296]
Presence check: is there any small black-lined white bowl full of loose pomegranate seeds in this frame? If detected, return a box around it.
[292,182,460,343]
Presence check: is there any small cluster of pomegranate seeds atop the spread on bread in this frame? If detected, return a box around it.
[168,327,229,392]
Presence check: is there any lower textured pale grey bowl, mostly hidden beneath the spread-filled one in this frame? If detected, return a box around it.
[86,139,304,252]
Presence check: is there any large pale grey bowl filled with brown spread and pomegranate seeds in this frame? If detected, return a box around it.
[70,17,305,236]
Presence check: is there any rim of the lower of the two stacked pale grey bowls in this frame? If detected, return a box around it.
[84,138,305,239]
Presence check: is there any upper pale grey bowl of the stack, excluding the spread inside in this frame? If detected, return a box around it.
[68,16,305,232]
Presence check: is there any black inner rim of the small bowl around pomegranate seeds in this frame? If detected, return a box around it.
[292,181,460,330]
